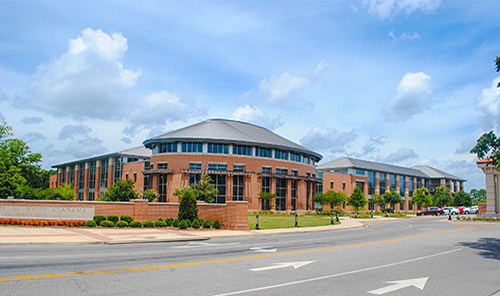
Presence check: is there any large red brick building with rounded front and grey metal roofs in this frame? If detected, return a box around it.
[51,119,465,211]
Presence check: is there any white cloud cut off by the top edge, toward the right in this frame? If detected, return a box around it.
[363,0,441,19]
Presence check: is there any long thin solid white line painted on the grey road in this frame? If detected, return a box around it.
[216,249,462,296]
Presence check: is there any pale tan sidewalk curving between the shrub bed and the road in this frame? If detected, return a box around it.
[0,217,365,247]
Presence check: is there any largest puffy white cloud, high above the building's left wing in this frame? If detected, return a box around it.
[15,28,141,119]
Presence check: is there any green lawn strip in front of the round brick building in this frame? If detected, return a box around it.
[248,214,339,230]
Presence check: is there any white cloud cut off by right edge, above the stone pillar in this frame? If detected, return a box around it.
[476,76,500,130]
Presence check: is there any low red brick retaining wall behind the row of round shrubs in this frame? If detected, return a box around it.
[0,199,249,230]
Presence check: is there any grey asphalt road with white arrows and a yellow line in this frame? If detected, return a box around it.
[0,217,500,296]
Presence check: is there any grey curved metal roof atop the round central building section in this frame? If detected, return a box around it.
[142,119,323,161]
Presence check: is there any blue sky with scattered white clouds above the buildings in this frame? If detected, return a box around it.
[0,0,500,191]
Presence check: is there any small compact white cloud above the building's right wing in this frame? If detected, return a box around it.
[382,72,436,121]
